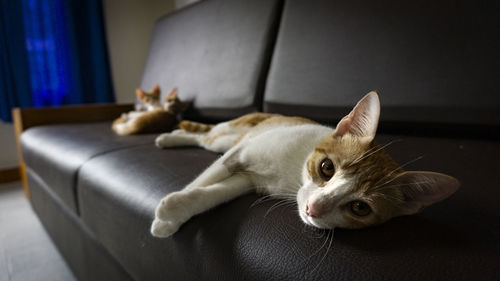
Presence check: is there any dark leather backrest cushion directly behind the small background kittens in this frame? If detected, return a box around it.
[141,0,282,120]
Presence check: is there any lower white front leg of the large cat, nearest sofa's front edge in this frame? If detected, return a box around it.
[151,174,253,237]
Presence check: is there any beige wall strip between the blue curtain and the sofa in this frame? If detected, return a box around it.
[104,0,175,103]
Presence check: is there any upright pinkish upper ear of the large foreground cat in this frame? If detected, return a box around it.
[334,91,380,142]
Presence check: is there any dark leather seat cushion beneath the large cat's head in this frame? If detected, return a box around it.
[78,135,500,280]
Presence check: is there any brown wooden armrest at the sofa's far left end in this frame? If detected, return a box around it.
[12,104,134,198]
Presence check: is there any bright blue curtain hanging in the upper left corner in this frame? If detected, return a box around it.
[0,0,114,121]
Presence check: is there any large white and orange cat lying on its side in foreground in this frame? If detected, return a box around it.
[151,92,459,237]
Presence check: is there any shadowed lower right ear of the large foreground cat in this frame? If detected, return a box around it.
[388,171,460,215]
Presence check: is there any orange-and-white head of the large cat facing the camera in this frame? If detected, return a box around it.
[297,92,460,229]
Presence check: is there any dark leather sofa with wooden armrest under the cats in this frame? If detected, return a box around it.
[15,0,500,281]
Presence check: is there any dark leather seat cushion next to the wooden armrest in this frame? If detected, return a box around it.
[21,122,156,212]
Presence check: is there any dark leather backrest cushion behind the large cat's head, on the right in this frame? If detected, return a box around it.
[264,0,500,136]
